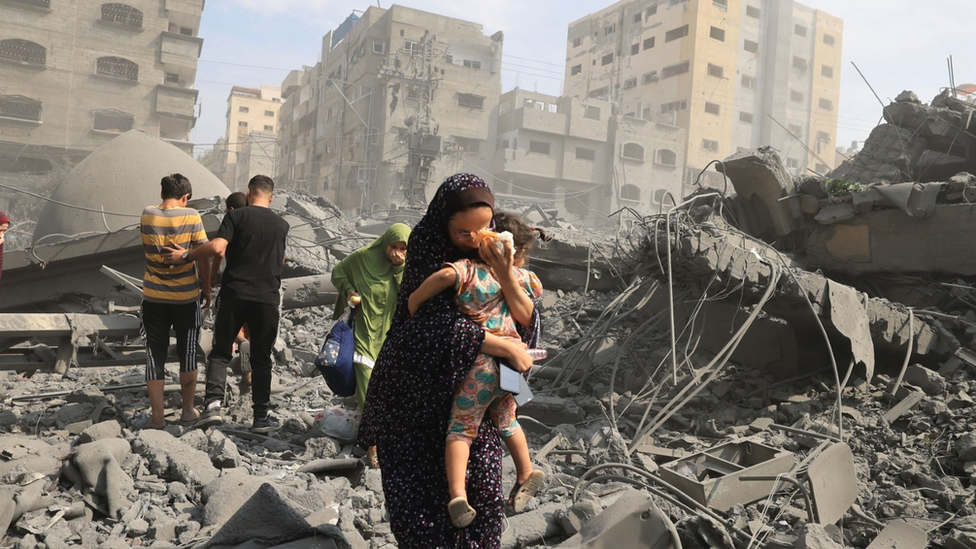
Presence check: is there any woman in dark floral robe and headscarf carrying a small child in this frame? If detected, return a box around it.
[359,174,539,549]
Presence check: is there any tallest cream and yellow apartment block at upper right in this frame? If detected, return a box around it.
[565,0,843,183]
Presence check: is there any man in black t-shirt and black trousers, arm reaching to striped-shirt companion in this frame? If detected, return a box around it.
[166,175,288,433]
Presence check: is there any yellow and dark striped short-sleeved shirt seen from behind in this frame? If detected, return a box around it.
[141,206,207,304]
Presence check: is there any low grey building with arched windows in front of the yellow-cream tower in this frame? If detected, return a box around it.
[492,88,685,225]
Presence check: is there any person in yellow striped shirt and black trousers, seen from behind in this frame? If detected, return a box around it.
[140,173,210,429]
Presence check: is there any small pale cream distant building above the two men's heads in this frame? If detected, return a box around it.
[215,84,281,191]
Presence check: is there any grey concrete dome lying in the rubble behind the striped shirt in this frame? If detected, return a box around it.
[33,130,230,244]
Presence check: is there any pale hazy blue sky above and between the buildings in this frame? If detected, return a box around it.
[193,0,976,151]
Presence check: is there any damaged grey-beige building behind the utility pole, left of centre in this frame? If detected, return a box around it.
[278,5,502,213]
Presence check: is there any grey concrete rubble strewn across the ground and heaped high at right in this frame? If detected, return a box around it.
[0,93,976,549]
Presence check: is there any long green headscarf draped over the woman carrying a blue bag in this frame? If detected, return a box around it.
[332,223,410,360]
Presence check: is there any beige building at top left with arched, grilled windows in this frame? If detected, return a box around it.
[0,0,204,175]
